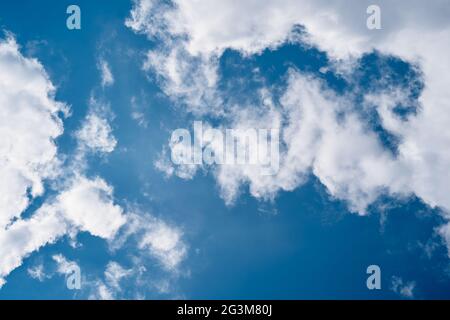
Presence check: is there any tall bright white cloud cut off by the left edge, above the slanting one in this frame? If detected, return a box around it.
[0,37,68,229]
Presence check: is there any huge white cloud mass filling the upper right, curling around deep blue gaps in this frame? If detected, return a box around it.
[126,0,450,252]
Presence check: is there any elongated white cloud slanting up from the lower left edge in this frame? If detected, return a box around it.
[0,177,126,284]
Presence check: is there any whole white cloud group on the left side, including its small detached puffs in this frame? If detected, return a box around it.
[0,37,185,287]
